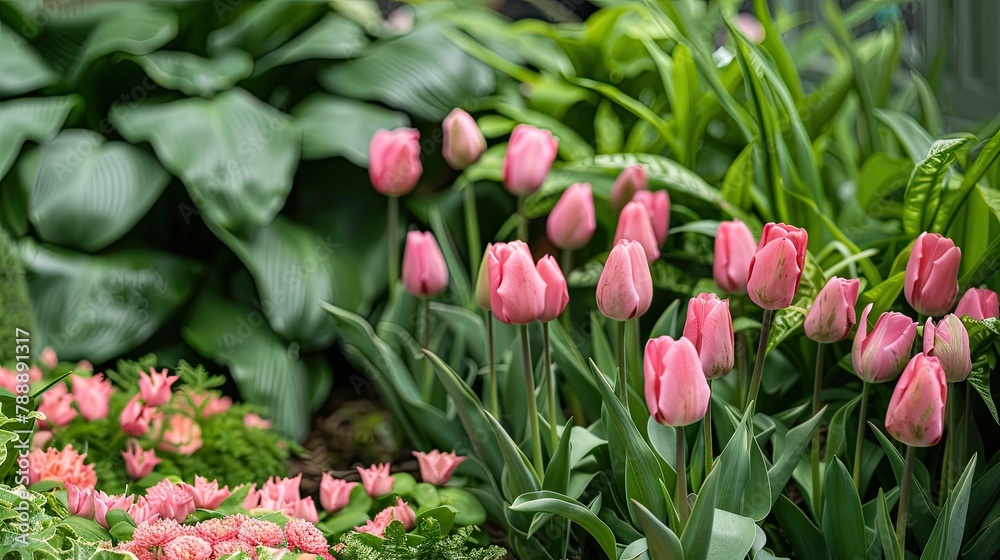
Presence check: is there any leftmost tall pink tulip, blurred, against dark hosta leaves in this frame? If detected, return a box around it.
[368,128,424,196]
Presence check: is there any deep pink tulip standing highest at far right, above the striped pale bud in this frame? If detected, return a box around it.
[903,232,962,317]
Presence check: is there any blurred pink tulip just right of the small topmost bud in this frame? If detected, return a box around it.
[503,124,559,196]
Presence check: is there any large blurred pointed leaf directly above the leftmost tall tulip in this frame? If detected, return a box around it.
[318,24,494,121]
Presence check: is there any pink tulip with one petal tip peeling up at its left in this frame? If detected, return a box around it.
[851,303,917,383]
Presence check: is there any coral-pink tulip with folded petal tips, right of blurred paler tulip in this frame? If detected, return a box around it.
[747,222,809,309]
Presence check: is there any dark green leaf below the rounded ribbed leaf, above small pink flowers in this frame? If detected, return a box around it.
[19,239,201,363]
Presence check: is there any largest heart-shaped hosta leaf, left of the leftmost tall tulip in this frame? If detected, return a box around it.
[111,88,300,231]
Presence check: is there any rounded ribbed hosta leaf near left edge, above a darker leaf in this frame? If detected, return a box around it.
[19,130,170,252]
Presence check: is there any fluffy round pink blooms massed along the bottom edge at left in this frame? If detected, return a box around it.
[117,515,332,560]
